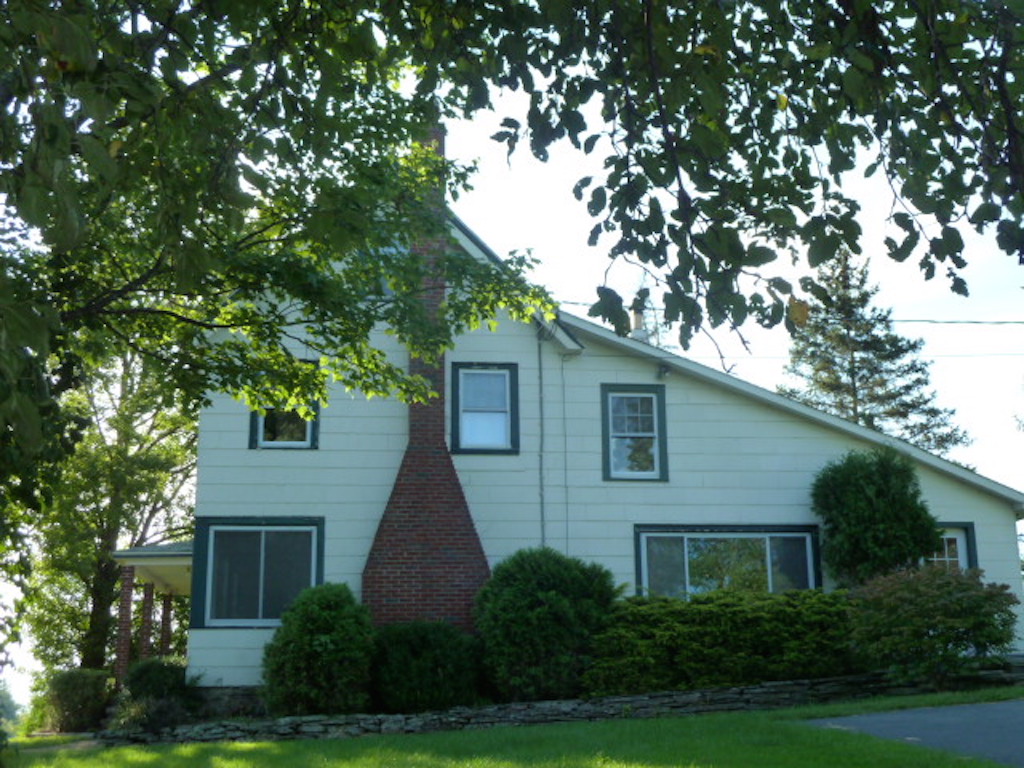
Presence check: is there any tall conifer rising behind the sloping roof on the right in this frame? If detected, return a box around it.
[779,253,970,456]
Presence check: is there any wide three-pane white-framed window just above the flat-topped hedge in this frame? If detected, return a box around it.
[640,529,816,597]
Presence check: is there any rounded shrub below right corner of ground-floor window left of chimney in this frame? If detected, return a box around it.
[263,584,374,715]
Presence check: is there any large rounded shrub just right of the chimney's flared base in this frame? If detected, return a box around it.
[476,548,618,700]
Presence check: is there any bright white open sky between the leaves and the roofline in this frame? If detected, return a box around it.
[445,114,1024,489]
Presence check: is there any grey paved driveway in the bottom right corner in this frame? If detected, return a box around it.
[810,699,1024,768]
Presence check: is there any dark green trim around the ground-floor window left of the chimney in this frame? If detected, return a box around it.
[190,517,324,629]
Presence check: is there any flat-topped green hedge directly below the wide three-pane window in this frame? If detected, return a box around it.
[585,590,857,695]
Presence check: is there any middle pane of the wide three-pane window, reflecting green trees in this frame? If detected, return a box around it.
[686,537,768,593]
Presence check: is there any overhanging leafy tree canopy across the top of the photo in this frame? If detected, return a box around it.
[0,0,1024,655]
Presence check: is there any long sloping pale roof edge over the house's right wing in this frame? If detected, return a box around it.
[557,311,1024,519]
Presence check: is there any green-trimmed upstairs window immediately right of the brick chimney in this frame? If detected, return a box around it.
[452,362,519,454]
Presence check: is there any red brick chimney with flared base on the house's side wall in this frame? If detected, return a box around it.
[362,126,490,630]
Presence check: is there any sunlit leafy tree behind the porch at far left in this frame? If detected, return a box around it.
[26,354,196,671]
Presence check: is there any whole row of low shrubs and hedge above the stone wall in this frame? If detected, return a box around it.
[256,549,1016,714]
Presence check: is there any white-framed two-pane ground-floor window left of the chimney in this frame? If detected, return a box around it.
[206,525,317,627]
